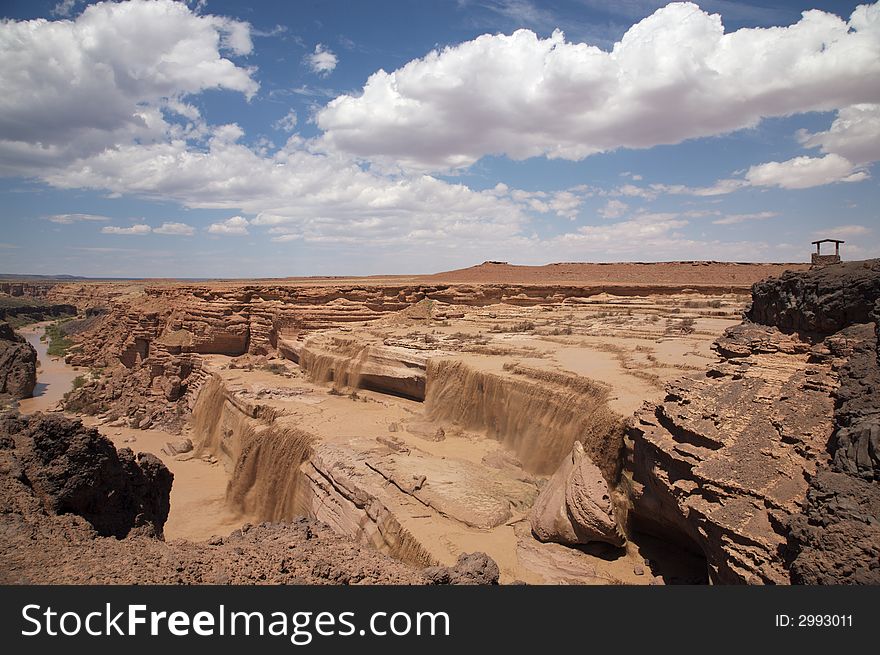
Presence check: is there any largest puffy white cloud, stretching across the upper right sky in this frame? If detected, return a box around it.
[316,3,880,169]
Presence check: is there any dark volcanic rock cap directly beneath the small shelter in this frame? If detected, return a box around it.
[746,259,880,336]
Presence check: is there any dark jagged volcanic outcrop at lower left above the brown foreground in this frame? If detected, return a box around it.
[0,414,174,538]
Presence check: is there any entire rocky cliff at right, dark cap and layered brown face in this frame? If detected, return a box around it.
[624,260,880,584]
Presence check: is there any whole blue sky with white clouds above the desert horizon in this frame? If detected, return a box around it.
[0,0,880,277]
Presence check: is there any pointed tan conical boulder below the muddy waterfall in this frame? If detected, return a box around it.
[530,441,626,546]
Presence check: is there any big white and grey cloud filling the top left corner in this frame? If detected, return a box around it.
[0,0,258,175]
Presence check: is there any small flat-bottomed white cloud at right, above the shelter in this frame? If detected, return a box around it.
[746,154,868,189]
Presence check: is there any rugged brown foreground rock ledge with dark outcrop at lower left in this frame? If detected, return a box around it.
[0,414,498,584]
